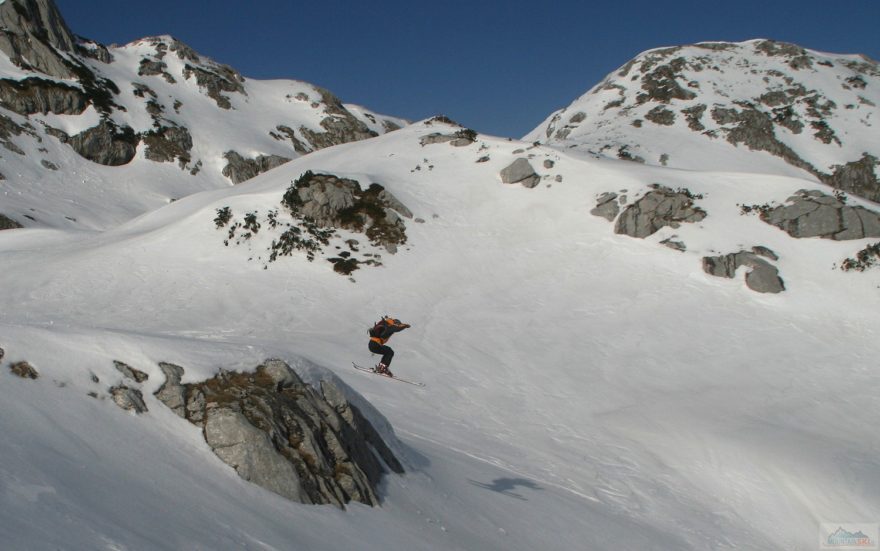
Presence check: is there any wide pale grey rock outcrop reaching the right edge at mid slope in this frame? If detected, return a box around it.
[745,190,880,241]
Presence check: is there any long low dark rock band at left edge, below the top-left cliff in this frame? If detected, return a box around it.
[0,77,89,115]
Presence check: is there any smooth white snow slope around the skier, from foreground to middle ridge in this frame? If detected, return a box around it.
[0,121,880,550]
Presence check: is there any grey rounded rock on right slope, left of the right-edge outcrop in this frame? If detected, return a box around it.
[614,184,706,238]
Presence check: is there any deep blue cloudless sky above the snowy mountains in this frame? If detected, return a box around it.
[56,0,880,137]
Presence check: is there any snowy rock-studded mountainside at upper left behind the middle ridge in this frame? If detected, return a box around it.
[0,0,406,229]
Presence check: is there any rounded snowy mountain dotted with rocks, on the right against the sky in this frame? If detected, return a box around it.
[524,40,880,201]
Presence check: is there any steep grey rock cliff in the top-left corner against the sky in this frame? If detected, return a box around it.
[0,0,76,78]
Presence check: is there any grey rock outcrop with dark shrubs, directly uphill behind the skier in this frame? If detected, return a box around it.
[283,171,412,253]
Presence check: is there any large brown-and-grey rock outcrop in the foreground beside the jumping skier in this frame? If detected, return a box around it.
[156,360,403,506]
